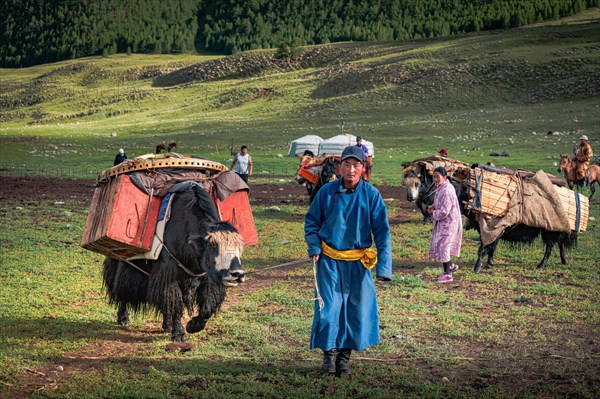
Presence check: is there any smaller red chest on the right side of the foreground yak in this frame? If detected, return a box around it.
[213,190,258,247]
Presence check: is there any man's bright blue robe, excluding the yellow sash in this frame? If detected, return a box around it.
[304,179,392,350]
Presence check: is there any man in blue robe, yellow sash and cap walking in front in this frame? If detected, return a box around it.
[304,146,392,375]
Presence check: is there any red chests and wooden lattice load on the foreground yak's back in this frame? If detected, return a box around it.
[81,153,258,259]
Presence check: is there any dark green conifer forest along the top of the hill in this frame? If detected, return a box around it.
[0,0,600,67]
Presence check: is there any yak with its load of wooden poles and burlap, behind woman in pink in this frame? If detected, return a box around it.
[403,157,589,272]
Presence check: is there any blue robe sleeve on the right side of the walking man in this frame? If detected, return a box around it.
[371,191,392,280]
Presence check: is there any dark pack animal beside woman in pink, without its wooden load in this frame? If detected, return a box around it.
[417,177,577,273]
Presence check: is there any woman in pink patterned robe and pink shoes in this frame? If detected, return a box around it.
[427,166,462,283]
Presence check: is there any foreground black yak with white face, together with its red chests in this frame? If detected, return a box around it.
[81,153,258,342]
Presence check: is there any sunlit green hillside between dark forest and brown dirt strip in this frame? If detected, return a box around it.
[0,9,600,181]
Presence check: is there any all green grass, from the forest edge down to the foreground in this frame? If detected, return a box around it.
[0,9,600,398]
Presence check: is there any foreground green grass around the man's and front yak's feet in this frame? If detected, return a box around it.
[0,201,600,398]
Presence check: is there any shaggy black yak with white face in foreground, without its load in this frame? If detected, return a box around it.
[103,182,245,342]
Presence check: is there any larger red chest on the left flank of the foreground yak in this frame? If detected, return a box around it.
[81,175,161,259]
